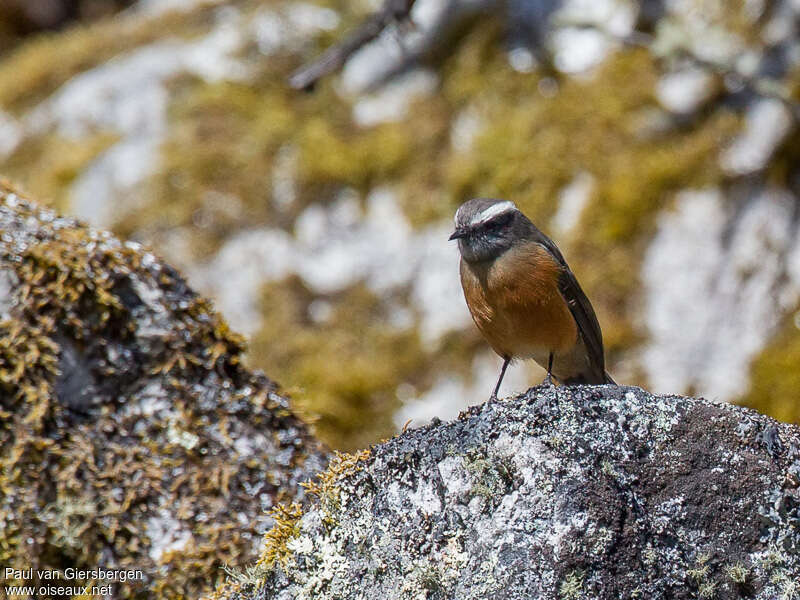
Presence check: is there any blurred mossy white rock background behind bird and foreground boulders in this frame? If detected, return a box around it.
[0,0,800,449]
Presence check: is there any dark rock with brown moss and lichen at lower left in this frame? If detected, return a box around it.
[0,184,326,598]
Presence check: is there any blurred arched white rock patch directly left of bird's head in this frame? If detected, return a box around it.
[190,188,470,344]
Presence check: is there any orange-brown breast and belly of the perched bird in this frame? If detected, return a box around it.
[461,244,578,366]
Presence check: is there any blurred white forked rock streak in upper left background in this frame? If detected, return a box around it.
[23,9,247,227]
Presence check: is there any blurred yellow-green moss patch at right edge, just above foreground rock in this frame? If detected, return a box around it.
[739,311,800,423]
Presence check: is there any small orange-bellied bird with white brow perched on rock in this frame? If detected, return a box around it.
[450,198,614,399]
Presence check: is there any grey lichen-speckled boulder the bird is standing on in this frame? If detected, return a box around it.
[223,385,800,600]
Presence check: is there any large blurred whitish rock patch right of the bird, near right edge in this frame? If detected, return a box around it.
[642,190,800,400]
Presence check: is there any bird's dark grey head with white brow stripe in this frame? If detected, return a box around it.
[450,198,526,262]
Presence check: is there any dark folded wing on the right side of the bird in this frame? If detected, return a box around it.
[536,230,605,380]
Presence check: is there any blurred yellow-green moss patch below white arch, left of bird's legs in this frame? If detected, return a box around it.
[251,278,425,449]
